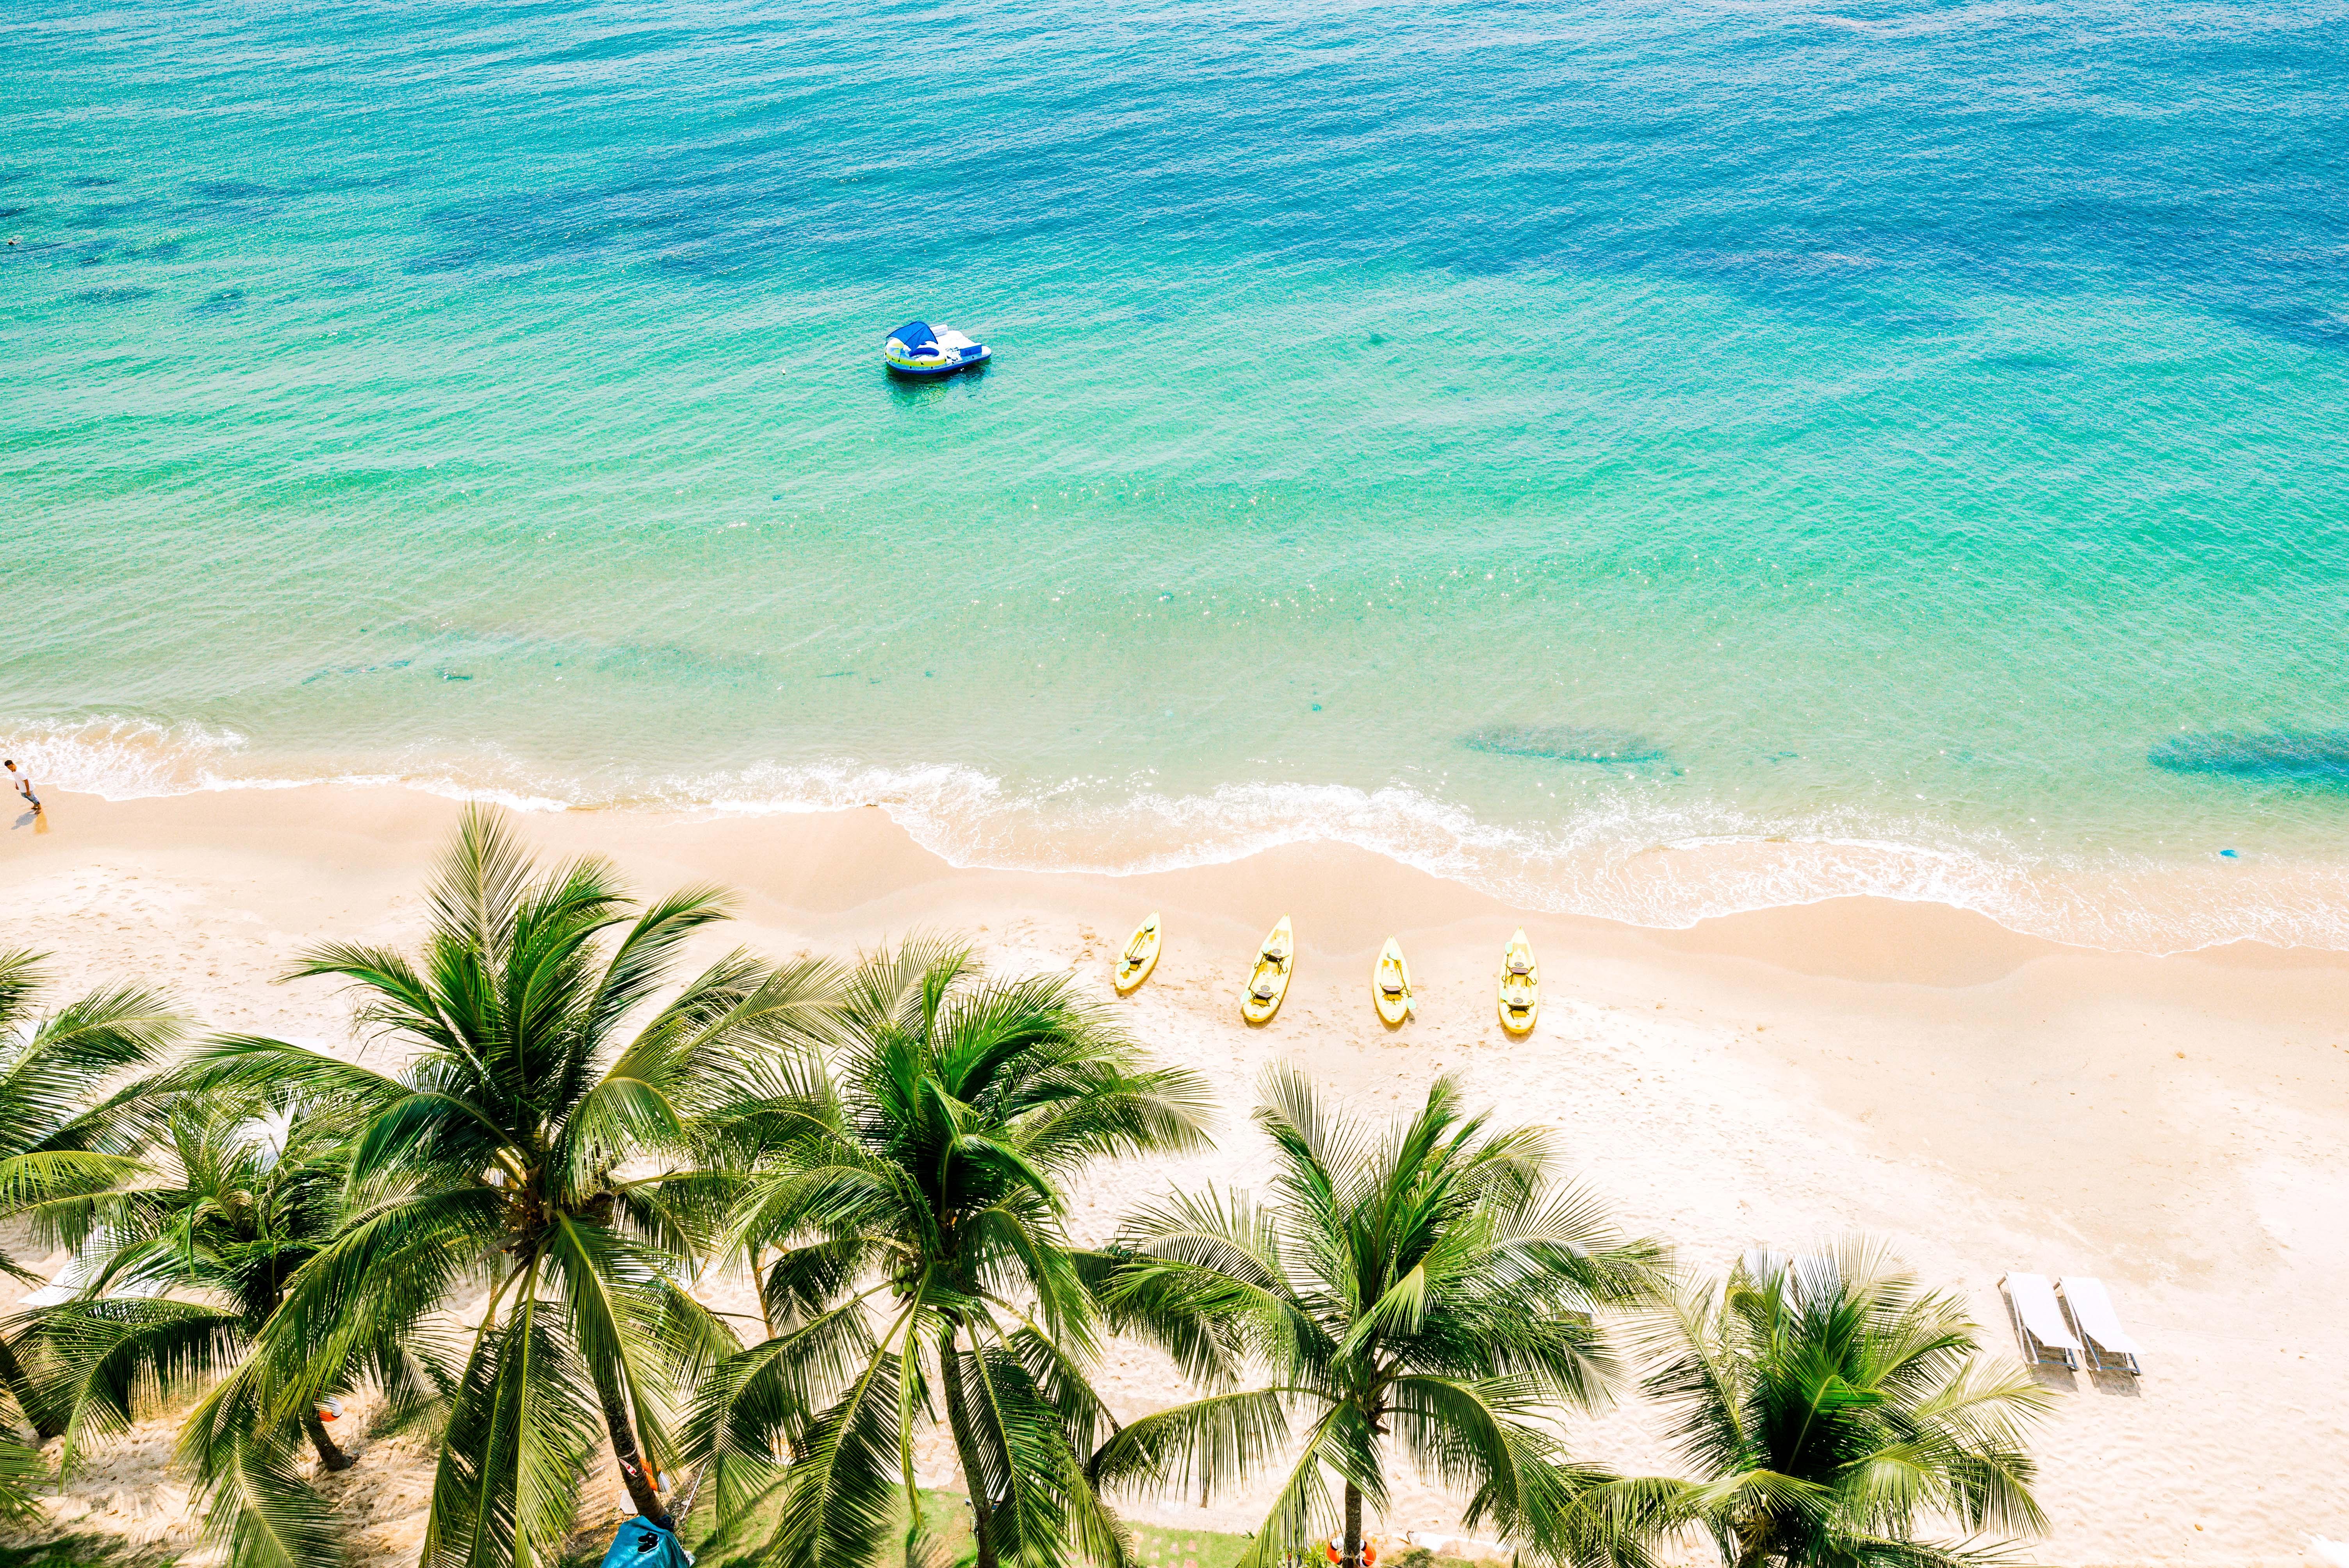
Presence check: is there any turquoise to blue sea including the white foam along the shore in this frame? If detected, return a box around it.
[0,0,2349,948]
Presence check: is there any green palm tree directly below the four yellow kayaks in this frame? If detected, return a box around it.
[1094,1068,1658,1568]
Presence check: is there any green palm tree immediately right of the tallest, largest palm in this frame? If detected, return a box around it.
[691,941,1205,1568]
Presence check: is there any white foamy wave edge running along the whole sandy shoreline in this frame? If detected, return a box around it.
[18,718,2349,953]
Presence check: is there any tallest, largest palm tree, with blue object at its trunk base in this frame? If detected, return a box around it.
[181,810,822,1568]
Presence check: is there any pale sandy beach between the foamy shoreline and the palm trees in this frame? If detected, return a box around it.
[0,786,2349,1566]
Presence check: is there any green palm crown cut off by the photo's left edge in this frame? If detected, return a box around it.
[0,951,188,1439]
